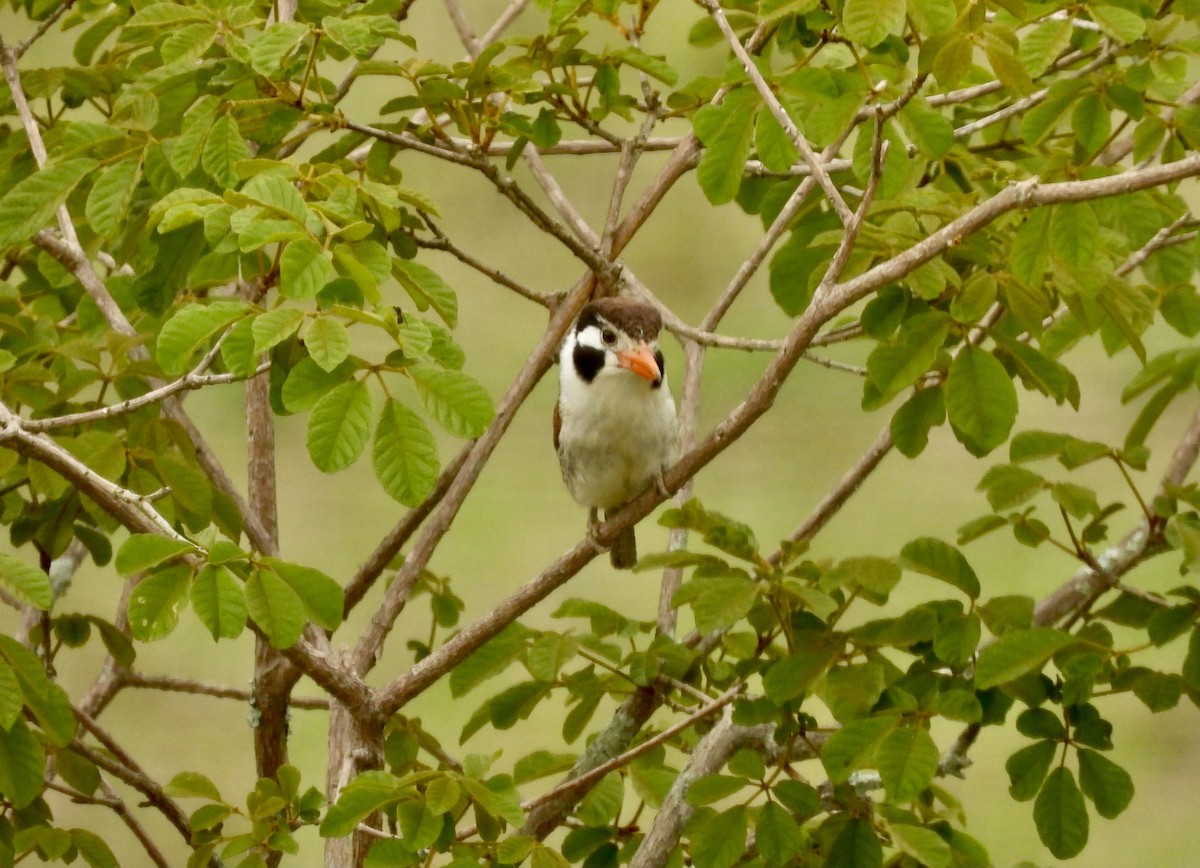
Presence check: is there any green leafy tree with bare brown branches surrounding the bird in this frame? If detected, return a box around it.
[0,0,1200,868]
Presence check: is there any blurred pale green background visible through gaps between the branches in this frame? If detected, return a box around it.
[0,0,1200,868]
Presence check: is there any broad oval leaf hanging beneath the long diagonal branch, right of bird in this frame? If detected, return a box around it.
[946,345,1016,457]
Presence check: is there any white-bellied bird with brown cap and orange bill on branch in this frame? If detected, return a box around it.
[554,298,678,569]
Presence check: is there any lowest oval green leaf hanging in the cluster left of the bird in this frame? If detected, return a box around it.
[371,397,438,507]
